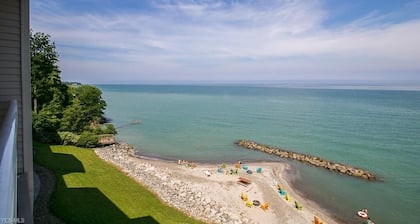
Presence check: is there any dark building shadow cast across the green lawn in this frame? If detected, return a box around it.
[35,144,159,224]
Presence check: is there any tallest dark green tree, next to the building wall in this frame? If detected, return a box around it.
[30,32,69,143]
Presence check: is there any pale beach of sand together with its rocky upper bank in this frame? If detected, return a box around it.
[95,144,337,223]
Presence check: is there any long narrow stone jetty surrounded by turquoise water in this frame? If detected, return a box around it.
[235,140,378,181]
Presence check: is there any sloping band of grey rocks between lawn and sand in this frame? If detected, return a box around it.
[95,143,249,224]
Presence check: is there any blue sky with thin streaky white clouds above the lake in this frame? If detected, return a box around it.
[30,0,420,84]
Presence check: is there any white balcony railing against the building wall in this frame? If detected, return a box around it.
[0,100,18,221]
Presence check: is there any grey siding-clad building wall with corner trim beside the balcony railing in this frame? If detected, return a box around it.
[0,0,33,208]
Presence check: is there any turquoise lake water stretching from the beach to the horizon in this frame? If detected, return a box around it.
[98,85,420,223]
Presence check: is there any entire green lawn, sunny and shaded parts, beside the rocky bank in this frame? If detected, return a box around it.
[34,143,201,224]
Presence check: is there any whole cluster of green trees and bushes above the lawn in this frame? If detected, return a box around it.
[30,31,117,147]
